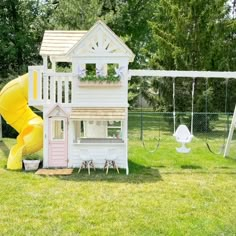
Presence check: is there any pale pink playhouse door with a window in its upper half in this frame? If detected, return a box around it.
[48,117,68,167]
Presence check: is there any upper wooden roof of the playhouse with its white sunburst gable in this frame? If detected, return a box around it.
[40,20,134,61]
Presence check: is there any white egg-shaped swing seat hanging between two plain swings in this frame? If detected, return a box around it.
[173,125,193,153]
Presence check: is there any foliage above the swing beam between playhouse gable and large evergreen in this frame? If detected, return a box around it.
[107,0,159,68]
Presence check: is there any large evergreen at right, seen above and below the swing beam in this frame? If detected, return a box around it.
[146,0,235,111]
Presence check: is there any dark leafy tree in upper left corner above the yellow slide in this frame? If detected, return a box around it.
[0,0,55,76]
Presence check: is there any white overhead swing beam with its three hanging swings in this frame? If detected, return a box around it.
[129,70,236,155]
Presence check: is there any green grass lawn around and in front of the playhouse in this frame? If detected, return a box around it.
[0,137,236,236]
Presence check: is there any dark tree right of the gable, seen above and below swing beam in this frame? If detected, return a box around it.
[103,0,161,110]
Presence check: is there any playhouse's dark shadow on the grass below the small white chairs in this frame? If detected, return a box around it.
[44,161,162,184]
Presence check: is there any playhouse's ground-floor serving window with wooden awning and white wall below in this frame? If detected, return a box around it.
[68,108,128,174]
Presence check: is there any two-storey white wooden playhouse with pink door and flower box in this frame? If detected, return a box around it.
[28,21,134,174]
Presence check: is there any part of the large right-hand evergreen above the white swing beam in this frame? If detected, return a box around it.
[149,0,229,70]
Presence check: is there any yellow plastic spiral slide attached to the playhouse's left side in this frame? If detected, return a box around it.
[0,74,43,170]
